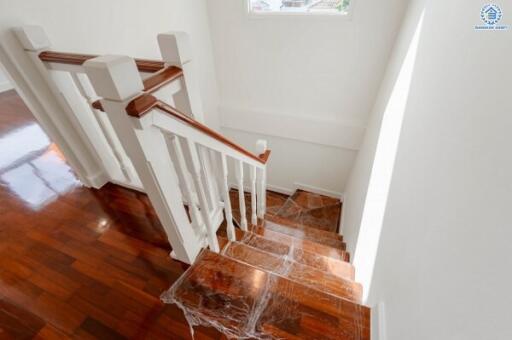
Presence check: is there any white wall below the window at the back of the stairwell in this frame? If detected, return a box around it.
[208,0,407,192]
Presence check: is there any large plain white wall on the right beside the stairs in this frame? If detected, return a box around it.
[345,0,512,340]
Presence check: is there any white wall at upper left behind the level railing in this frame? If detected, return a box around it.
[0,0,218,128]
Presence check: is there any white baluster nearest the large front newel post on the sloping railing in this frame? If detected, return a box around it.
[166,136,204,234]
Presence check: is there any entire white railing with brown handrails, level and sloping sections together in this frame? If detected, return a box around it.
[14,26,269,263]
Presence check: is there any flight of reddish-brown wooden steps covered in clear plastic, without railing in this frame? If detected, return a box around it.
[162,190,370,340]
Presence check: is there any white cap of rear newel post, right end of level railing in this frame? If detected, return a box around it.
[158,31,192,66]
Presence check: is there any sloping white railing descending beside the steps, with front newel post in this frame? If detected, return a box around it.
[84,49,268,263]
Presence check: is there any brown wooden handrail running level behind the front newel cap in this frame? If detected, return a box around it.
[39,51,165,73]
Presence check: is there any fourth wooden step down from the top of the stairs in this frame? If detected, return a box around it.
[262,215,346,250]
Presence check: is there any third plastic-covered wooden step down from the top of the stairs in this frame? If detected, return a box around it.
[219,229,355,281]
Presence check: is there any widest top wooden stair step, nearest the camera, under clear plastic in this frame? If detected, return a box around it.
[166,251,370,340]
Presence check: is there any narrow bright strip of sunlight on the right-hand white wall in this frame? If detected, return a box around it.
[354,6,425,301]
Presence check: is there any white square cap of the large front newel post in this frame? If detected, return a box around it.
[84,55,144,101]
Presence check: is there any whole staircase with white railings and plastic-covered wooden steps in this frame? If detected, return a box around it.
[14,26,370,340]
